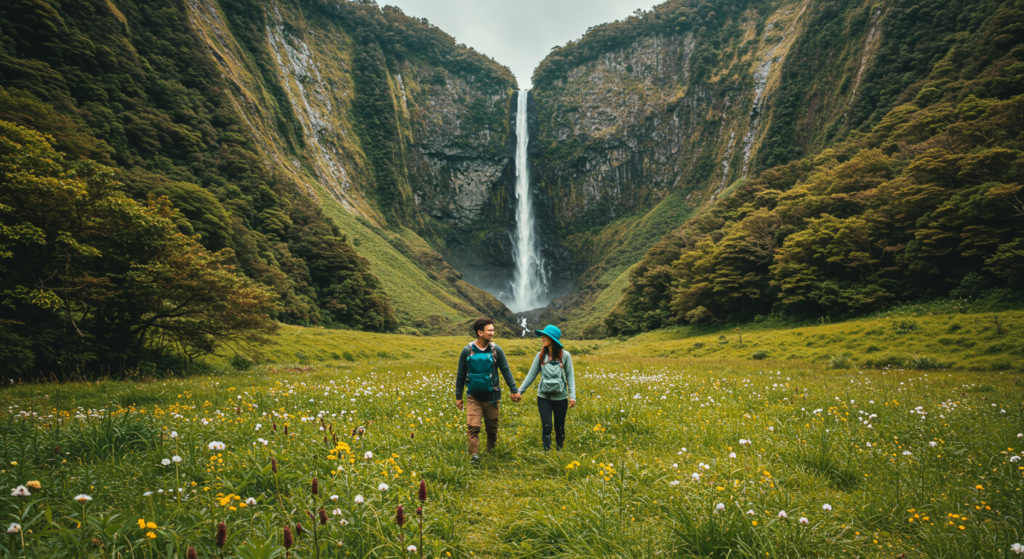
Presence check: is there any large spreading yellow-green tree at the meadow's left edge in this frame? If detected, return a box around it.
[0,121,278,374]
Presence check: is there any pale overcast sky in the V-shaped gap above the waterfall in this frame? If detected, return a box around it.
[378,0,660,89]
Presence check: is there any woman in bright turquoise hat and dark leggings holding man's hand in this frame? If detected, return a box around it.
[519,325,575,450]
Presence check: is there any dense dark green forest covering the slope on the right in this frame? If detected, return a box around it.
[605,2,1024,334]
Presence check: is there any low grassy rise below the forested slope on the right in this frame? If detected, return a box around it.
[614,307,1024,371]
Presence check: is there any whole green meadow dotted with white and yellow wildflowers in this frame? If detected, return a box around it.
[0,309,1024,558]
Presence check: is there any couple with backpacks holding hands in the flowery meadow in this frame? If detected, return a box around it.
[455,318,575,462]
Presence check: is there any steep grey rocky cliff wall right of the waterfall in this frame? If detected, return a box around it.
[535,0,954,336]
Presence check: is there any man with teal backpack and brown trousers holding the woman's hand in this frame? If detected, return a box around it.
[455,318,520,462]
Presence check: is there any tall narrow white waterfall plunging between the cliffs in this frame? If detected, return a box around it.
[509,90,547,312]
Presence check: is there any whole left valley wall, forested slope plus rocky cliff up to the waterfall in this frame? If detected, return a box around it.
[0,0,515,333]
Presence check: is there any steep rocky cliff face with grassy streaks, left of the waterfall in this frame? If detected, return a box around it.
[180,0,514,330]
